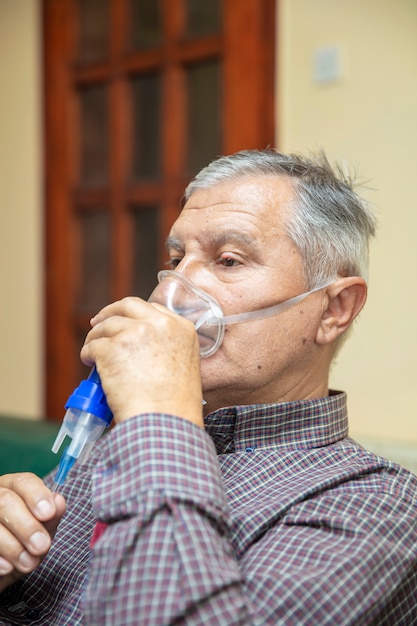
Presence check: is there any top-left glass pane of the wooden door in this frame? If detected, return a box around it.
[78,0,109,62]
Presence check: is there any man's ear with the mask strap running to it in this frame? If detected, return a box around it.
[316,276,368,344]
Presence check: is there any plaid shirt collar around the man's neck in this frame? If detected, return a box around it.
[205,391,348,454]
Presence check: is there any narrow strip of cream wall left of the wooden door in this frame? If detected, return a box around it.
[0,0,43,418]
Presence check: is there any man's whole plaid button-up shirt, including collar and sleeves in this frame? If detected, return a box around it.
[0,394,417,626]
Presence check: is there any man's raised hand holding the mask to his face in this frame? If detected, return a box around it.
[81,298,203,427]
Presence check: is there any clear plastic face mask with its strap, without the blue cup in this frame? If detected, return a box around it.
[149,270,336,358]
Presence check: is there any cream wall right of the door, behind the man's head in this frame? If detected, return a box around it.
[277,0,417,444]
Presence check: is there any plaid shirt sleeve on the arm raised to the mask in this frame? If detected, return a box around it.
[84,415,250,626]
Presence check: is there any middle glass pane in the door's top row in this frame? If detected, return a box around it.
[130,0,162,50]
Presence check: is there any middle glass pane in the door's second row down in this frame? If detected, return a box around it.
[132,74,161,180]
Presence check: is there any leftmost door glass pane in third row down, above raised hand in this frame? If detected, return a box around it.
[77,210,110,315]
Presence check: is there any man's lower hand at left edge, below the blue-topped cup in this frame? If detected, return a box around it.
[0,472,65,592]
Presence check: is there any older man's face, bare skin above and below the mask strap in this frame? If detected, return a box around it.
[168,176,327,410]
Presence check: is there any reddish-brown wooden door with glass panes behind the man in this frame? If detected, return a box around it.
[43,0,276,419]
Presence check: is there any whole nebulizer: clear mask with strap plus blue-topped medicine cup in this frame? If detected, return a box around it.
[52,270,337,490]
